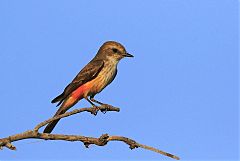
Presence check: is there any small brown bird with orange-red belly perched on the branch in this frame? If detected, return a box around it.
[43,41,134,133]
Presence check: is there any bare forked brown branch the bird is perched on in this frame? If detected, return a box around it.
[0,105,180,160]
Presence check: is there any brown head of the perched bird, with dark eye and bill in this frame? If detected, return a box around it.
[97,41,133,61]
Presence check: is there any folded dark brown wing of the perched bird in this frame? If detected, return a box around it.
[52,59,104,106]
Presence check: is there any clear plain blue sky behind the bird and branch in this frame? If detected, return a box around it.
[0,0,239,160]
